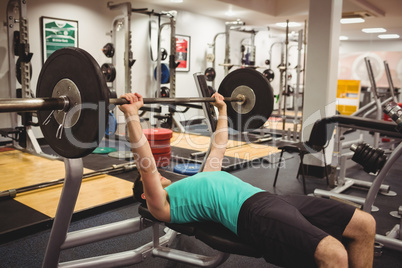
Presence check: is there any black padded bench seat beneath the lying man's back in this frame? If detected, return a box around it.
[138,205,262,258]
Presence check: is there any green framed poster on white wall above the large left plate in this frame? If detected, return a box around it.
[41,17,78,62]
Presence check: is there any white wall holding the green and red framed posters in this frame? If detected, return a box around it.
[0,0,229,136]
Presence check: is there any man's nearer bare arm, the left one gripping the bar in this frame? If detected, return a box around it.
[119,93,170,221]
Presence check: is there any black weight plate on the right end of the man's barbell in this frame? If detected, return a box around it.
[218,68,274,131]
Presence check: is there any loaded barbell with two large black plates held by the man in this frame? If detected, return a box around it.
[0,47,274,158]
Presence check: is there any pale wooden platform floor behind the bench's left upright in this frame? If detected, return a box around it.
[0,150,133,218]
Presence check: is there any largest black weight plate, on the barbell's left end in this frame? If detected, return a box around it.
[36,47,109,158]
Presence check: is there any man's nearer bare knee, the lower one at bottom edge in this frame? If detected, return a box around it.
[314,235,348,268]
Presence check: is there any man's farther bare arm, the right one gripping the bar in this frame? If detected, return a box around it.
[202,93,228,171]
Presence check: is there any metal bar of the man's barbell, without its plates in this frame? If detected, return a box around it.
[0,95,246,113]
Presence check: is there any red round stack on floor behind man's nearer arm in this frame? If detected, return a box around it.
[143,128,173,167]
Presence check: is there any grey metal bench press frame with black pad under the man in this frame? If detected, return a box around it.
[43,73,262,268]
